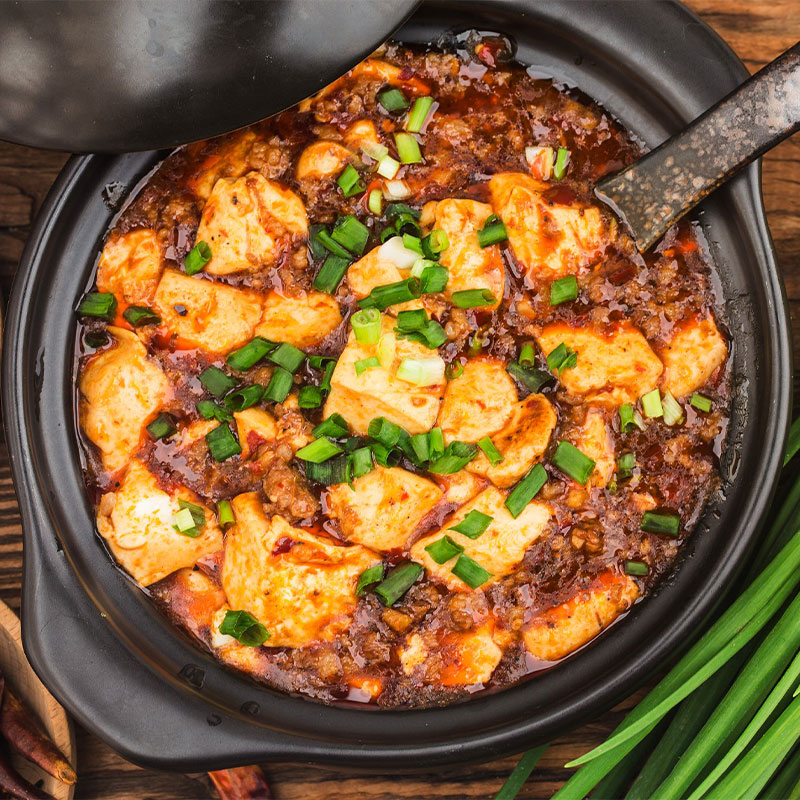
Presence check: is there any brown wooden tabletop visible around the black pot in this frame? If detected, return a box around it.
[0,0,800,800]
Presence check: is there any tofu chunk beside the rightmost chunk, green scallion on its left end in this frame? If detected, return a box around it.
[536,322,664,405]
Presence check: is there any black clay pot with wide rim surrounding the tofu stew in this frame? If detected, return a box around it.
[3,0,791,771]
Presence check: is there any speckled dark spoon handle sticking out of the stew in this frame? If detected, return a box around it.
[595,42,800,252]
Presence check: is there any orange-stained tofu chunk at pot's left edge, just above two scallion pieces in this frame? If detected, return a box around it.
[97,228,162,305]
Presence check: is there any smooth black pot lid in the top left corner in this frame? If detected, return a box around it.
[0,0,420,152]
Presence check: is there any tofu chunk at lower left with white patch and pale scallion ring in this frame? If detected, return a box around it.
[97,459,222,586]
